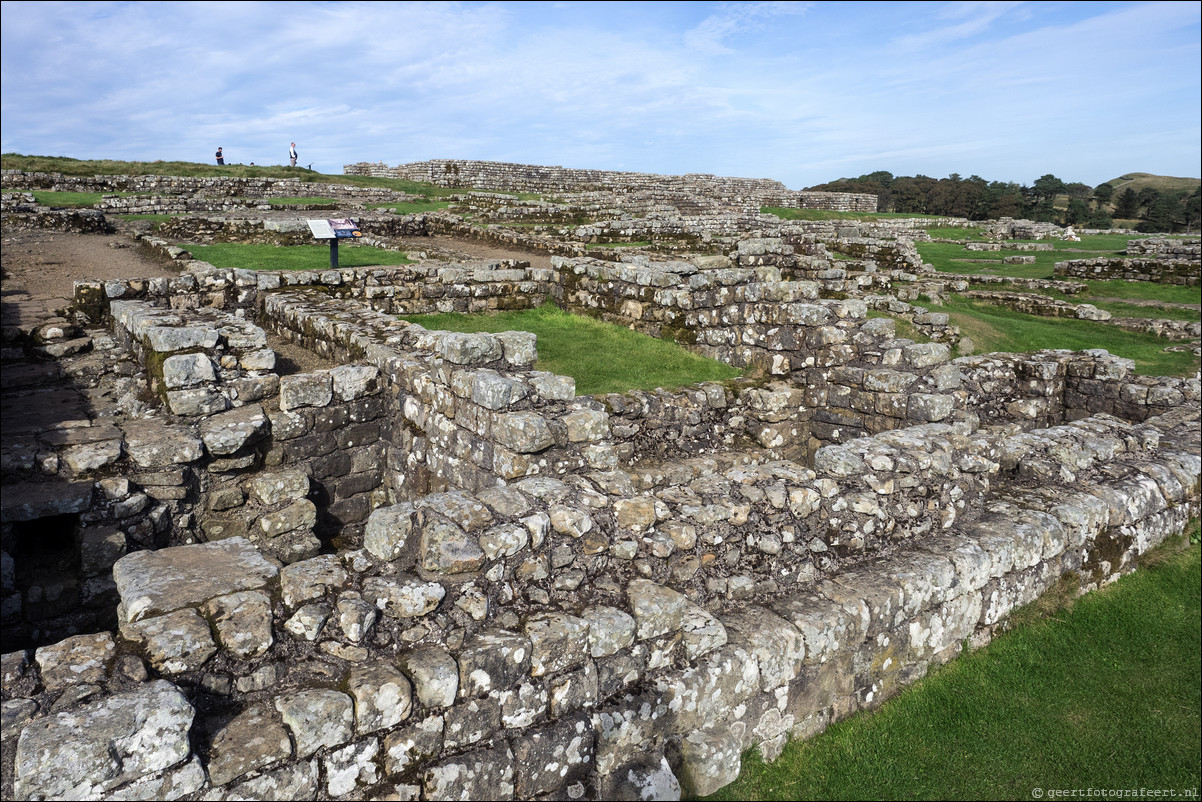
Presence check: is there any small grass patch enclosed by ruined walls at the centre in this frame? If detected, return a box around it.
[405,303,740,396]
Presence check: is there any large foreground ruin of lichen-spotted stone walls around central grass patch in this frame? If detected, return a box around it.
[0,241,1202,798]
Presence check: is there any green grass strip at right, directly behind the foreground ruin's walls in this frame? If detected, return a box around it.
[928,296,1198,376]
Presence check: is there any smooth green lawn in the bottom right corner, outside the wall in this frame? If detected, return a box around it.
[710,538,1202,800]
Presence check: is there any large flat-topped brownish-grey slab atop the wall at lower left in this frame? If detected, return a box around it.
[113,537,279,622]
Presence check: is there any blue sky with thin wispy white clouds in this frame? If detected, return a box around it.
[0,2,1202,189]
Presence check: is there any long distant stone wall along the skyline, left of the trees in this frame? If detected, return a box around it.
[343,159,877,212]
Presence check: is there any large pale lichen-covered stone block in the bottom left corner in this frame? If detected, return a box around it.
[13,679,194,800]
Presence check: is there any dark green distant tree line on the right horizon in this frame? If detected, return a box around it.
[808,170,1202,232]
